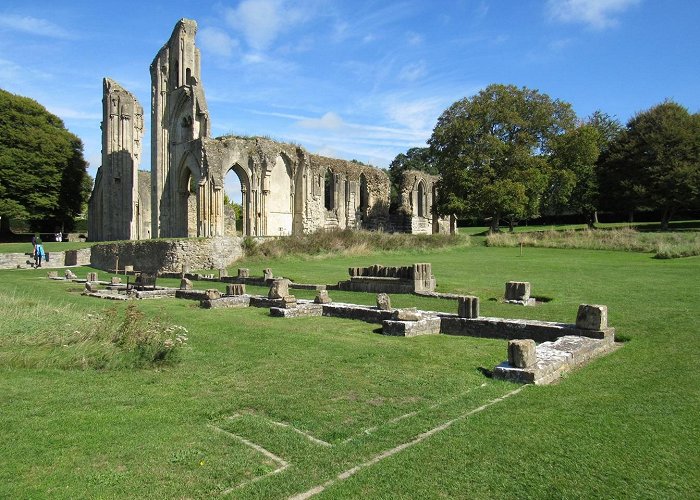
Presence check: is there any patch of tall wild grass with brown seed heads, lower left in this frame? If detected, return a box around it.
[0,291,187,370]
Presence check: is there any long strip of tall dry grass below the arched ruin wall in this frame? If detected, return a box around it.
[245,229,470,258]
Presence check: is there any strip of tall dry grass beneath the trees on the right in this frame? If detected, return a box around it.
[486,228,700,259]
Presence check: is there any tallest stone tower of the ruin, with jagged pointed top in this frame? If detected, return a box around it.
[151,19,210,238]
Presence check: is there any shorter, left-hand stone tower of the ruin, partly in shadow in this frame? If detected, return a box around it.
[88,78,151,241]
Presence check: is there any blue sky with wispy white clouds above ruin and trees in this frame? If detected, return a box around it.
[0,0,700,188]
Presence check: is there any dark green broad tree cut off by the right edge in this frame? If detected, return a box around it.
[601,101,700,229]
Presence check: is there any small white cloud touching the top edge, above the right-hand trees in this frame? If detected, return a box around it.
[547,0,641,29]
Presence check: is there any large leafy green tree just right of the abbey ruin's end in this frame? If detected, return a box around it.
[429,84,576,230]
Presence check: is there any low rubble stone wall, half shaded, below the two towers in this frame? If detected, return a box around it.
[91,237,243,272]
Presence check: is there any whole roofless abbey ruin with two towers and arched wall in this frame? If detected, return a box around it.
[88,19,449,241]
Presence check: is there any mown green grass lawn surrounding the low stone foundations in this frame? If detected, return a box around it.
[0,245,700,498]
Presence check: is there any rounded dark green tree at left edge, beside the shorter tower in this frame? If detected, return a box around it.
[0,89,91,231]
